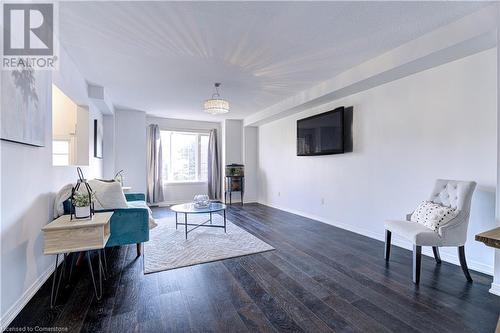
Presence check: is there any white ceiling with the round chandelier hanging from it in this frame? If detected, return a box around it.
[59,2,484,121]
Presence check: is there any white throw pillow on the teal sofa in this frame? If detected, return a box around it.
[86,179,128,210]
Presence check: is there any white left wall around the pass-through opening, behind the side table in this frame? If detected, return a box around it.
[0,48,102,327]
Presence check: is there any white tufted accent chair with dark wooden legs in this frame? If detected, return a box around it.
[385,179,476,284]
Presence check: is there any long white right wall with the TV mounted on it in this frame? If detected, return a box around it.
[259,49,497,274]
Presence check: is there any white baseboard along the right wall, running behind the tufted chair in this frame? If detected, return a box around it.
[259,201,494,274]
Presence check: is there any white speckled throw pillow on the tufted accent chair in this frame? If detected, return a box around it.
[410,201,458,232]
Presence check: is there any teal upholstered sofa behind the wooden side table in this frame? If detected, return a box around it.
[64,193,149,256]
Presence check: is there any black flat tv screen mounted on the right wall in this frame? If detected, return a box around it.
[297,107,344,156]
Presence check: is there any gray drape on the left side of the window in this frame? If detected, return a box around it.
[147,125,163,203]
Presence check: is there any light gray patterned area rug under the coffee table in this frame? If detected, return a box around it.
[144,214,274,274]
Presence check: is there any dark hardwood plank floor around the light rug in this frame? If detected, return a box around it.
[10,204,500,332]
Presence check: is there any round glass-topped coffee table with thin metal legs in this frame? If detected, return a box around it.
[170,202,227,239]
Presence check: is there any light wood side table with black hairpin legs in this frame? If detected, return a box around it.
[42,212,113,307]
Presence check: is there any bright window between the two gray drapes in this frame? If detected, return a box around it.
[161,131,208,183]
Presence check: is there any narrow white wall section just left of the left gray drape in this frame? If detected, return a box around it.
[115,110,146,193]
